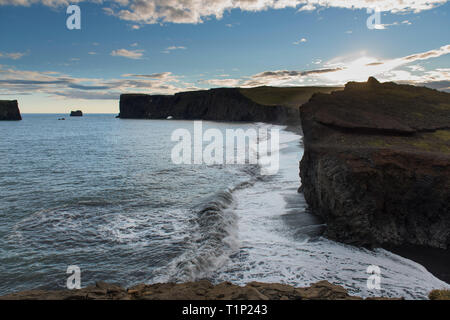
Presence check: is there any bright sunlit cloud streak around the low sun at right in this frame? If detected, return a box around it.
[201,45,450,87]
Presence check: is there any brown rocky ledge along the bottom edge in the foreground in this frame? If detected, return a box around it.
[0,281,400,300]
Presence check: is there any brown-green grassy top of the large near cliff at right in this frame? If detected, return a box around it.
[301,78,450,157]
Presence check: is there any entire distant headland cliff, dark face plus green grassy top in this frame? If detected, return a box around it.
[119,87,340,124]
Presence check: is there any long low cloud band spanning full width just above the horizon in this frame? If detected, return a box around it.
[0,45,450,99]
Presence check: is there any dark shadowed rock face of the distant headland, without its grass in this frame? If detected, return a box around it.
[119,88,299,123]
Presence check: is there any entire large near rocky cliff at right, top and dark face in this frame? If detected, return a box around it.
[300,78,450,249]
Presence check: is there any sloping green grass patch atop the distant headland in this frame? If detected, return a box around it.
[239,86,343,108]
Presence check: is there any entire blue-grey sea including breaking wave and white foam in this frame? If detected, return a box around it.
[0,114,449,299]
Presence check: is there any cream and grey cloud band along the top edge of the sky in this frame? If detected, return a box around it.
[0,0,447,24]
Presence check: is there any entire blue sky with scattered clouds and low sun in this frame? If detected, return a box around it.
[0,0,450,113]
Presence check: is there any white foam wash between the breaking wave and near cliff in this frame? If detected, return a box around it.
[214,125,449,299]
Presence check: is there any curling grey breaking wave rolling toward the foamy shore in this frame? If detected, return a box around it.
[151,131,267,282]
